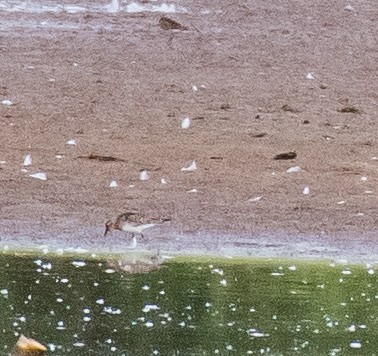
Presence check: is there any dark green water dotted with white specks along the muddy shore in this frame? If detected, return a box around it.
[0,254,378,356]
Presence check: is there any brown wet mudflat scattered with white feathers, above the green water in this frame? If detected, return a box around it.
[0,0,378,260]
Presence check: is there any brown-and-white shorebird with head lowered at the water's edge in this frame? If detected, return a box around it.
[104,212,171,248]
